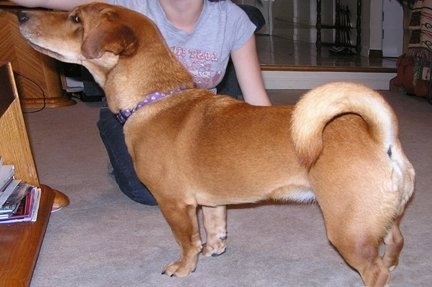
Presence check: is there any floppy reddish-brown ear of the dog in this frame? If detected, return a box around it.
[81,10,138,59]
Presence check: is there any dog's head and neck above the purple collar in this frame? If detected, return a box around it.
[18,3,193,109]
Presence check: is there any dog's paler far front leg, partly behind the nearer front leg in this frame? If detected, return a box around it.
[202,206,227,256]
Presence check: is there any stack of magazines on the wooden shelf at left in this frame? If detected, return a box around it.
[0,158,41,224]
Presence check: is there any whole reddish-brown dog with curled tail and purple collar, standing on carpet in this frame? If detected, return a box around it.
[19,3,414,286]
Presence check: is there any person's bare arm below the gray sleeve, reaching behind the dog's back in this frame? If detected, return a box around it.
[231,35,271,106]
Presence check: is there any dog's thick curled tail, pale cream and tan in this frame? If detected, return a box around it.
[291,82,398,168]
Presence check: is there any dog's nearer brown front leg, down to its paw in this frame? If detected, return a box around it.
[158,201,202,277]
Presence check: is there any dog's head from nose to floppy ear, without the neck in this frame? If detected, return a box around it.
[18,3,143,63]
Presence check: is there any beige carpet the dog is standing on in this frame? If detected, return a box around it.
[26,91,432,287]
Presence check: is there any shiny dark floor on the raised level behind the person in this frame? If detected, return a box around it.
[256,34,396,73]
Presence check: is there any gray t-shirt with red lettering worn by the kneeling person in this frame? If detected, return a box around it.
[109,0,255,89]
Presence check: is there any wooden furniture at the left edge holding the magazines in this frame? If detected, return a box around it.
[0,63,66,287]
